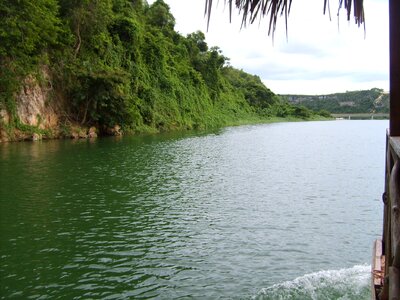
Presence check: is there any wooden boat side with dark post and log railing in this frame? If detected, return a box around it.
[372,0,400,300]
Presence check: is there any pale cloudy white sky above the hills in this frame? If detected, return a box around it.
[148,0,389,95]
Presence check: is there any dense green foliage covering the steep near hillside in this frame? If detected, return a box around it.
[0,0,324,135]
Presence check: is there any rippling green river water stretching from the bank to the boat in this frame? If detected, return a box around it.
[0,120,388,300]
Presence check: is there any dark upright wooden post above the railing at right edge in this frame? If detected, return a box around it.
[389,0,400,136]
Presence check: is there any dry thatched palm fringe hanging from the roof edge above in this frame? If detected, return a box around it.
[204,0,365,35]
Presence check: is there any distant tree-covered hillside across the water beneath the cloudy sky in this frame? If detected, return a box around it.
[282,88,389,114]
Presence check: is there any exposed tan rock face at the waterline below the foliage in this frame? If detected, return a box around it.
[0,68,122,143]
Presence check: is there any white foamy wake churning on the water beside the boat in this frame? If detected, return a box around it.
[253,265,371,300]
